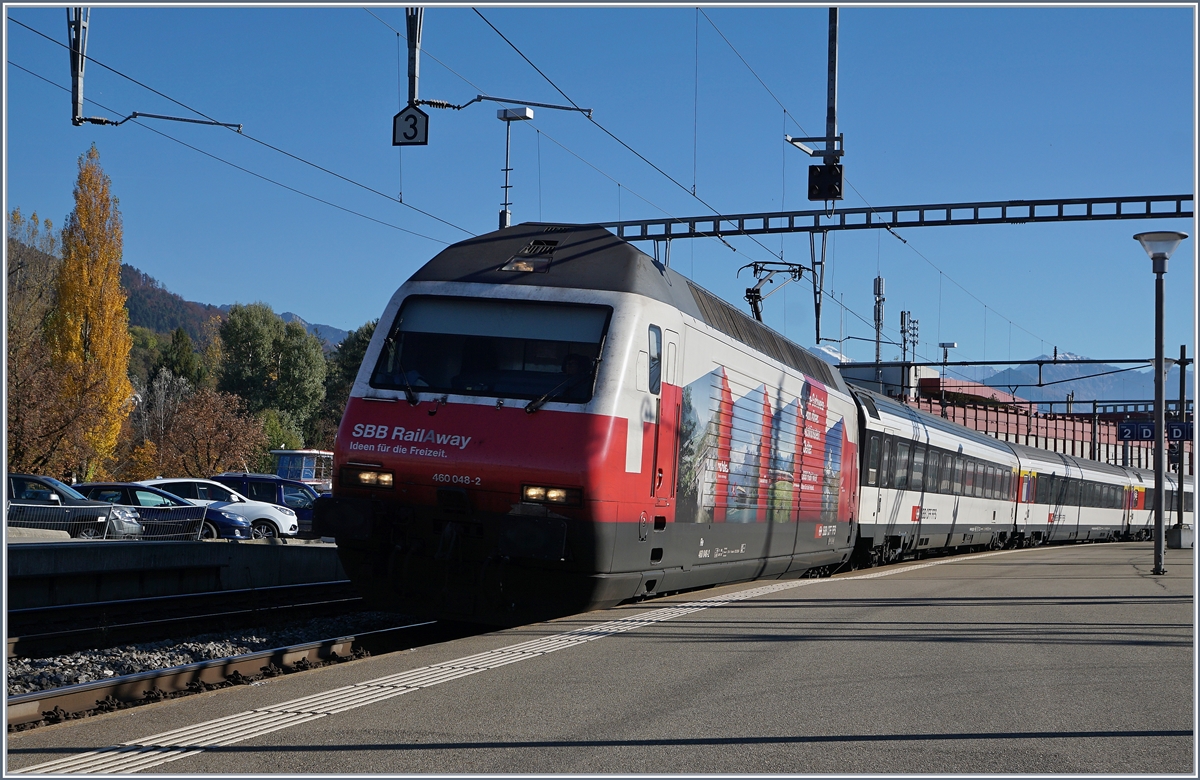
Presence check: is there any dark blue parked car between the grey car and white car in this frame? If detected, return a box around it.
[76,482,252,540]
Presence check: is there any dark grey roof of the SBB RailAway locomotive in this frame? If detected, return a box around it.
[410,222,848,392]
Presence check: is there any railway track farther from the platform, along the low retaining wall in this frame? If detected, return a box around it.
[6,580,364,658]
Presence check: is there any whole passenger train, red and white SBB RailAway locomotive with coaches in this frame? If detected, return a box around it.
[318,224,1190,624]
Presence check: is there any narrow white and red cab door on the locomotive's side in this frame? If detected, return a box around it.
[648,325,683,504]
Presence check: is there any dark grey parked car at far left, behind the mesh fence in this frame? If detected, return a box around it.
[7,474,142,539]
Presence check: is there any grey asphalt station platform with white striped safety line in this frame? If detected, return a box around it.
[6,542,1196,775]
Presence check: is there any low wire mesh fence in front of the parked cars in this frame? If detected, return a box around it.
[6,502,205,541]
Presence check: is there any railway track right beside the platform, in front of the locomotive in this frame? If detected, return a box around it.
[6,620,486,731]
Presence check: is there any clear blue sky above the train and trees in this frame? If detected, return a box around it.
[5,6,1196,369]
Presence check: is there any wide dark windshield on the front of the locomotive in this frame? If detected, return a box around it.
[371,295,612,403]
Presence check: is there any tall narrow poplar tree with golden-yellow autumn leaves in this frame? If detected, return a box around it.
[46,145,134,479]
